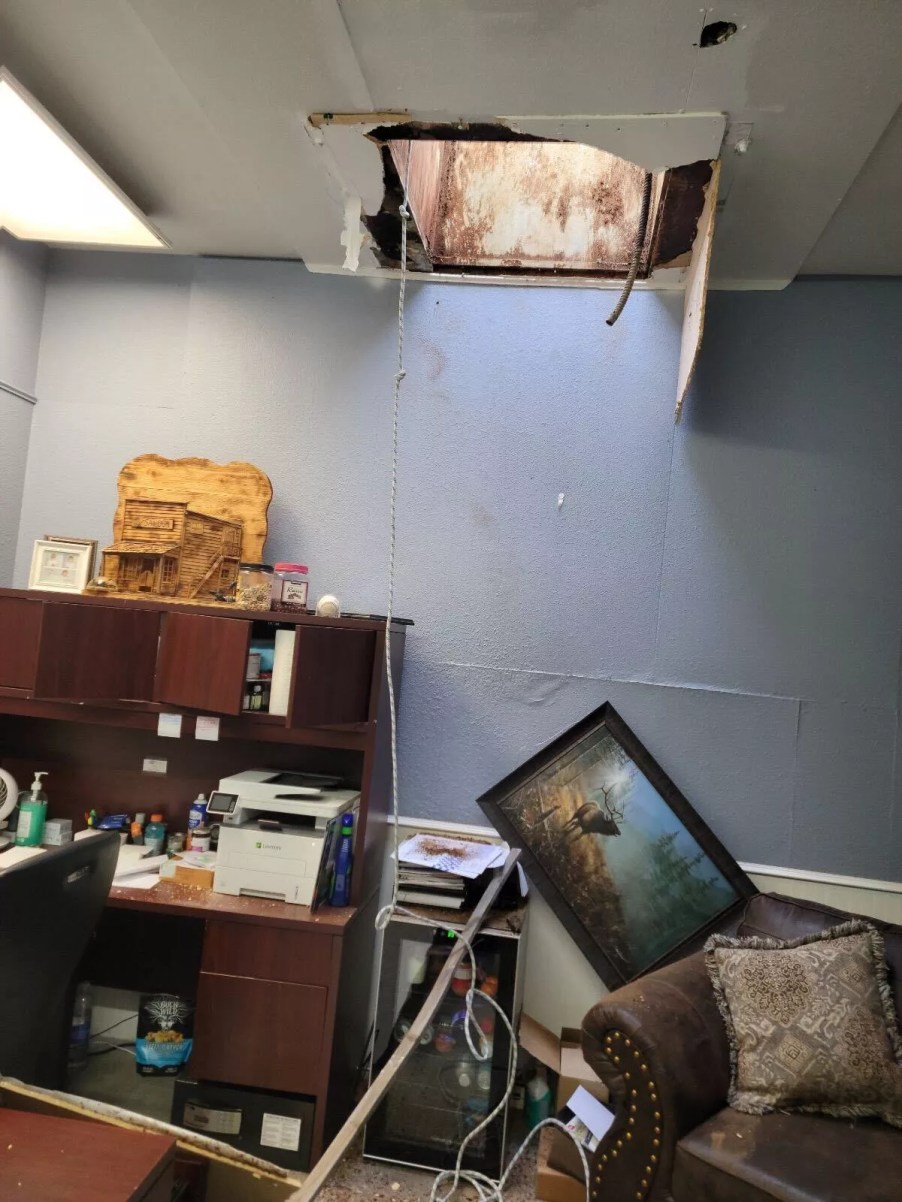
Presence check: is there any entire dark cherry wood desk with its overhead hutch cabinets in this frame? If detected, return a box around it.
[0,589,404,1161]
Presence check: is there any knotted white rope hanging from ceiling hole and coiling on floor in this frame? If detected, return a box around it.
[375,159,589,1202]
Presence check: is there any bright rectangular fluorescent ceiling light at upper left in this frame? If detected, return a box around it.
[0,67,167,248]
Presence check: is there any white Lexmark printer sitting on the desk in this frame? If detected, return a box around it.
[207,769,360,905]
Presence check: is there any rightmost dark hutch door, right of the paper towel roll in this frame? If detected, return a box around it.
[289,625,376,726]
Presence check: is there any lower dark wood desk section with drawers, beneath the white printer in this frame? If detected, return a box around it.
[96,881,376,1160]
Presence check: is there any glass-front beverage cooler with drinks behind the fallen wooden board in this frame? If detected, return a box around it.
[363,915,526,1178]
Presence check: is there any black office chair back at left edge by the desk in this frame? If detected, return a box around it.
[0,831,120,1089]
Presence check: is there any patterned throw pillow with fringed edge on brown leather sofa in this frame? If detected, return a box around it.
[705,922,902,1126]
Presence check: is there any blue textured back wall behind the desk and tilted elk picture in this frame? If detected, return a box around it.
[17,254,902,879]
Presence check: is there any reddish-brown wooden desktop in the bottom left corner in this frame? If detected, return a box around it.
[0,1107,176,1202]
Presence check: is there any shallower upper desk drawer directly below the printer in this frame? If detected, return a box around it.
[201,921,332,984]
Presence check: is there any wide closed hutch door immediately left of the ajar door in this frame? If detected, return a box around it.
[34,601,160,701]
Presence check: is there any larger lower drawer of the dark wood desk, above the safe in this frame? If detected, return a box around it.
[191,972,328,1094]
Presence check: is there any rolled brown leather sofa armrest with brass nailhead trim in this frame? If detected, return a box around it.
[582,953,730,1202]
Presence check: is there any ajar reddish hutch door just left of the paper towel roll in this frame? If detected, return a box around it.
[155,613,250,714]
